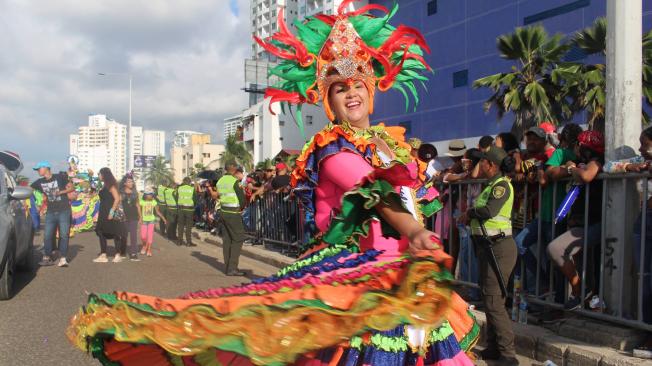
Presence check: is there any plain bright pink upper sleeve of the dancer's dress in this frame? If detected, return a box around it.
[319,151,373,191]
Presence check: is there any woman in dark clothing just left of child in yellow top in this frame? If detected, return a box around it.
[120,174,141,262]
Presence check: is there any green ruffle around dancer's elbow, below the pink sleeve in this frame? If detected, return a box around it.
[322,179,408,247]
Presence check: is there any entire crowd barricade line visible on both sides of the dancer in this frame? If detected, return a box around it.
[239,174,652,331]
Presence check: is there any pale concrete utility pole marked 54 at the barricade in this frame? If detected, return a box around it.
[602,0,643,316]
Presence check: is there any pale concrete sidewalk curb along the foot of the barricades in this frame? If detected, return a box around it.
[192,229,652,366]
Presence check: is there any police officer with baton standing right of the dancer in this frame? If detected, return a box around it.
[460,146,518,365]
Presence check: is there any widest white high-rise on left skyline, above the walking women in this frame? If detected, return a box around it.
[69,114,127,177]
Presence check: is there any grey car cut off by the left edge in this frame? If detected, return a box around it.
[0,151,34,300]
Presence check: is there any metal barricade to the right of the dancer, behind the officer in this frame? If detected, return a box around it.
[438,173,652,331]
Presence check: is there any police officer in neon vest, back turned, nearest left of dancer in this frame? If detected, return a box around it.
[216,174,245,274]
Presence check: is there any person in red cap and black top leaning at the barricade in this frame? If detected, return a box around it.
[548,131,604,310]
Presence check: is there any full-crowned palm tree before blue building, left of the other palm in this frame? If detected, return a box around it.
[473,25,572,136]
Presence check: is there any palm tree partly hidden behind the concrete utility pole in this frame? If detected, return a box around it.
[553,18,652,130]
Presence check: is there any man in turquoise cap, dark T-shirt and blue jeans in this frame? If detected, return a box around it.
[32,161,75,267]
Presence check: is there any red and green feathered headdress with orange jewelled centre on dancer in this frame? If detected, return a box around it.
[254,0,430,134]
